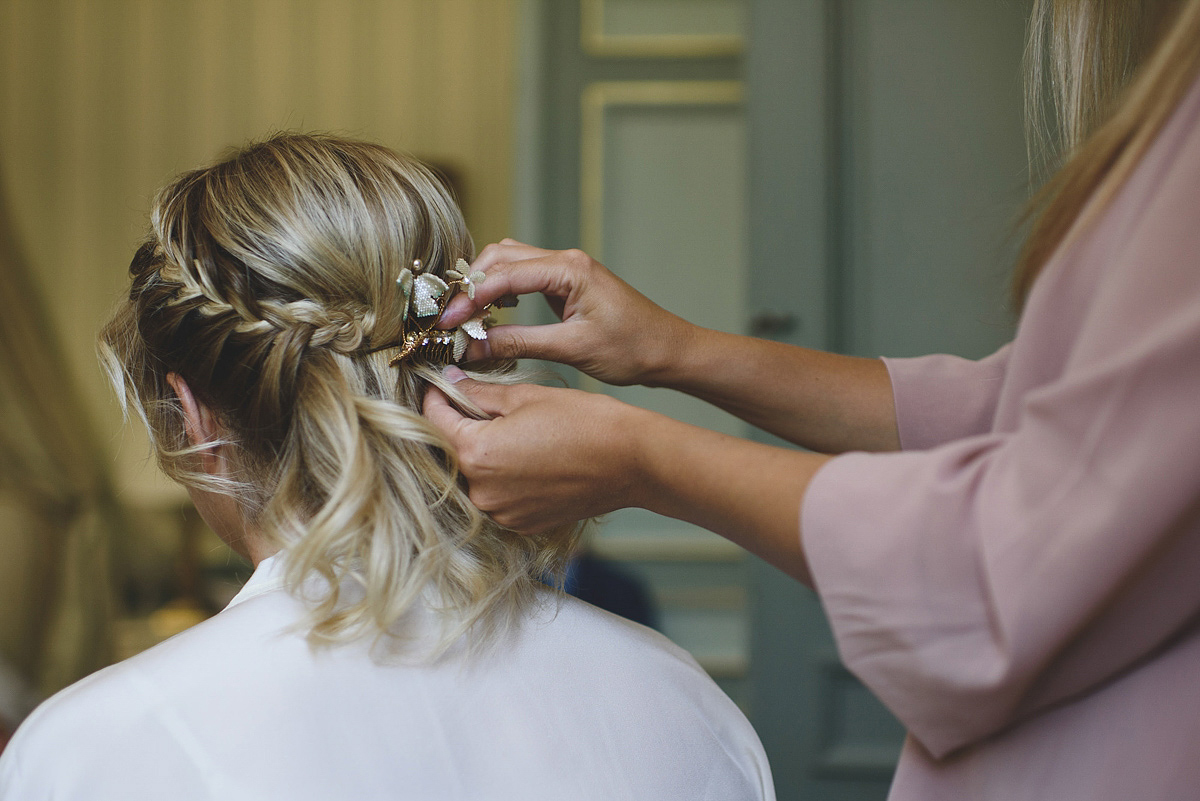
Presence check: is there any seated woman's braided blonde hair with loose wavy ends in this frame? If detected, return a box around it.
[101,134,577,654]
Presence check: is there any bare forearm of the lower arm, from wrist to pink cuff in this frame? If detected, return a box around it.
[626,412,830,584]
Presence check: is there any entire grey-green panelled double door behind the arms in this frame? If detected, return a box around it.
[515,0,1026,800]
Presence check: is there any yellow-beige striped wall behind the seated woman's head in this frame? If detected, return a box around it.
[0,0,516,505]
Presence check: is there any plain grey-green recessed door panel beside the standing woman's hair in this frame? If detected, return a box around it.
[839,0,1028,357]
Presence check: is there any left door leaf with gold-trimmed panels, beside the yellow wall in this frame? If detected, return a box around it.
[532,0,750,704]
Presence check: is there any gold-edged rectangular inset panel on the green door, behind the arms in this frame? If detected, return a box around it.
[581,80,748,435]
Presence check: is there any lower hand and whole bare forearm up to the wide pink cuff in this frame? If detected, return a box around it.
[425,367,829,582]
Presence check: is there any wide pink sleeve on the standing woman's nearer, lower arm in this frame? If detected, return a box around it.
[802,84,1200,757]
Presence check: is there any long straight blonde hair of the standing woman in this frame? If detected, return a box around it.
[1013,0,1200,305]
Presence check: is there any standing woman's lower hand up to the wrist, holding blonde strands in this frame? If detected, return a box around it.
[425,367,650,534]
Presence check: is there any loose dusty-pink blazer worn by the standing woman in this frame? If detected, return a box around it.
[800,71,1200,801]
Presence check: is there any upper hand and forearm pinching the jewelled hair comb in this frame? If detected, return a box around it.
[440,240,900,453]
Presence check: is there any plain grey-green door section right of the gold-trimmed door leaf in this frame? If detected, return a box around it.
[746,0,1027,801]
